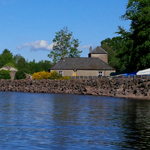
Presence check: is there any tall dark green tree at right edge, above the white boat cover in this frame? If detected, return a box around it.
[118,0,150,70]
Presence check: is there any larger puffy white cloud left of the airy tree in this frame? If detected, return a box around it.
[17,40,54,51]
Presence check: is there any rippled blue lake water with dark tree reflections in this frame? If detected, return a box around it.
[0,92,150,150]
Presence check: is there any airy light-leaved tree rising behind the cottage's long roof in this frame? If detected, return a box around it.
[48,27,82,64]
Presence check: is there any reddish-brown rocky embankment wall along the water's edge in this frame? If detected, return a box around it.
[0,76,150,100]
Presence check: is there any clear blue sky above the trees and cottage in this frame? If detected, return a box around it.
[0,0,130,62]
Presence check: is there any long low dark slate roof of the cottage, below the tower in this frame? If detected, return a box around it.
[51,57,114,70]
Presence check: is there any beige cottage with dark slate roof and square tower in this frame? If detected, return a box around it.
[50,46,115,76]
